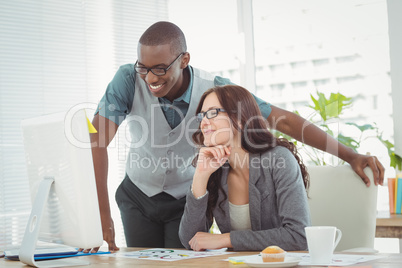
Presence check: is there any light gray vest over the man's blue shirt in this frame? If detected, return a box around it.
[126,68,214,199]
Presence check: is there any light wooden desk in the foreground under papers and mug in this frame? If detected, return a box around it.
[0,248,402,268]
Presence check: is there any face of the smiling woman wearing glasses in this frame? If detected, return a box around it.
[200,92,234,147]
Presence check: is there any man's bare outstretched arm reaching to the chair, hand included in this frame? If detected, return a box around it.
[267,105,384,186]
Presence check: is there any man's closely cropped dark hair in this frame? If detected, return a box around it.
[139,21,187,54]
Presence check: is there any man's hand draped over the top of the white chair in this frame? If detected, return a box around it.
[349,154,385,187]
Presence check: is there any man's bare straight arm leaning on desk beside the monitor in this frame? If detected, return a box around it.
[91,114,119,252]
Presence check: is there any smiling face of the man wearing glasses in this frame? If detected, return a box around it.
[137,44,187,100]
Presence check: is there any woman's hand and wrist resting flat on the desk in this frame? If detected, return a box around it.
[189,232,232,251]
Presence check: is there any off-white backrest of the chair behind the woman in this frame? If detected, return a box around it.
[307,165,377,251]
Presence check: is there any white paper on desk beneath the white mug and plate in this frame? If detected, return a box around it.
[286,252,385,266]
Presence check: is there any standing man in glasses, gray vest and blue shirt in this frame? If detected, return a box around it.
[91,22,384,251]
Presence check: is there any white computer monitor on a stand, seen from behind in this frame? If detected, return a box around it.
[19,109,103,267]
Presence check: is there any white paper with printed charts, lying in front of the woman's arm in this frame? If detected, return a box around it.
[110,248,234,261]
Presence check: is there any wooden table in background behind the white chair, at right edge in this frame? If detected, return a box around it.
[375,211,402,253]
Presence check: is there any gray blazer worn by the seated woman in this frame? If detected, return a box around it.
[179,146,311,251]
